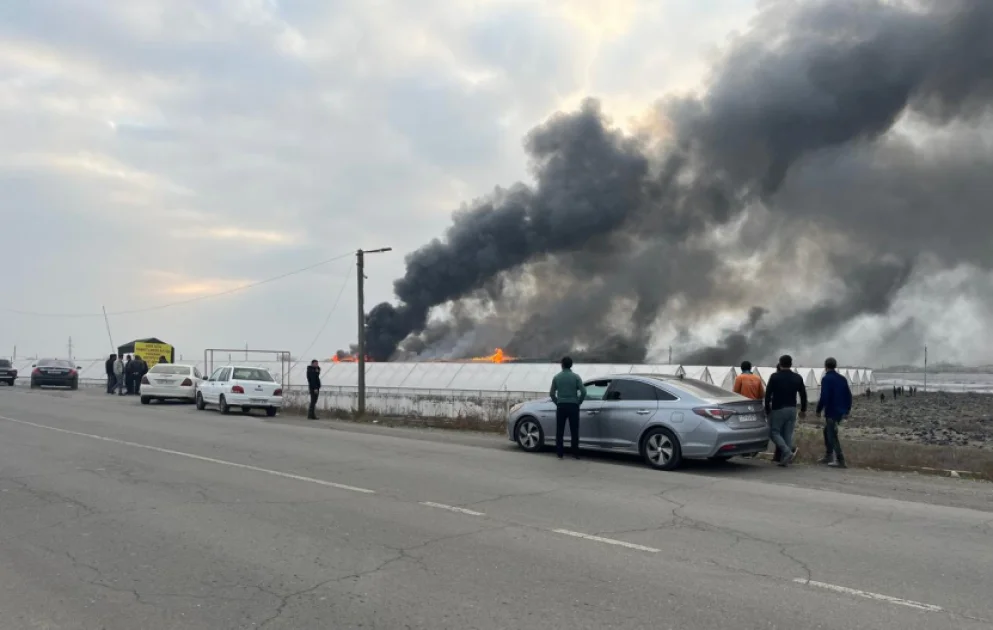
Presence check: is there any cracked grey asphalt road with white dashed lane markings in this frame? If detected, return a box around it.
[0,388,993,630]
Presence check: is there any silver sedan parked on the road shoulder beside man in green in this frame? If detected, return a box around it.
[507,374,769,470]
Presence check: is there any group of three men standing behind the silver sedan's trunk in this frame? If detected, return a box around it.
[734,354,852,468]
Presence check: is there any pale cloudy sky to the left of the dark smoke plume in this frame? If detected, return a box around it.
[0,0,755,358]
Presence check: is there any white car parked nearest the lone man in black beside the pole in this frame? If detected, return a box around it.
[196,365,283,417]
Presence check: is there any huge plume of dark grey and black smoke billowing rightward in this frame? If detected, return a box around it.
[367,0,993,364]
